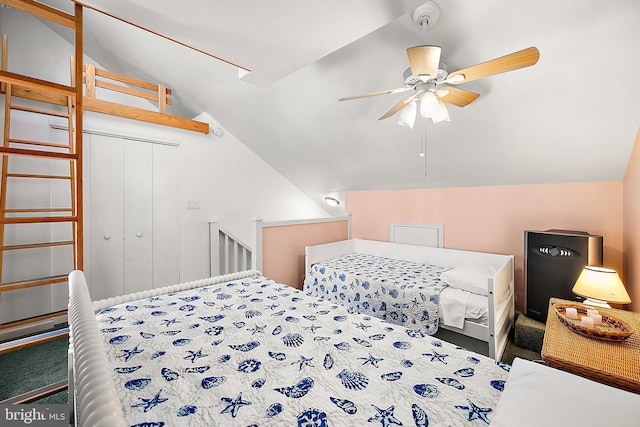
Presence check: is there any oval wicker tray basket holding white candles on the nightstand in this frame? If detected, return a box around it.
[554,303,633,341]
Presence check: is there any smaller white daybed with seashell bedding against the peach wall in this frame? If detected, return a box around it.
[303,239,515,360]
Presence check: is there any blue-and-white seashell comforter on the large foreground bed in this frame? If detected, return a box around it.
[96,276,509,427]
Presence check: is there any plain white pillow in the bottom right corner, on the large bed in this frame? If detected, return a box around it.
[489,358,640,427]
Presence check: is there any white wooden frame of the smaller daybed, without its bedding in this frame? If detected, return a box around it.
[305,239,515,360]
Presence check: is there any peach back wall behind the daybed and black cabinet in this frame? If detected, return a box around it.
[345,181,624,311]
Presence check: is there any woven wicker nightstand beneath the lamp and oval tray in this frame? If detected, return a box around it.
[542,298,640,394]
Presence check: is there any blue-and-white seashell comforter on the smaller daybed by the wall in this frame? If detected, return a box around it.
[304,254,449,335]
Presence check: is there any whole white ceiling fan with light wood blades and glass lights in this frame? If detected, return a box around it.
[339,1,540,128]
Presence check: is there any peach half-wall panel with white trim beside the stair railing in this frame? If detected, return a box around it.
[262,220,349,289]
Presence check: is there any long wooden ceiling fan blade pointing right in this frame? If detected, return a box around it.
[446,47,540,84]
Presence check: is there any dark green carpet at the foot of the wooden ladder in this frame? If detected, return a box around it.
[0,338,69,403]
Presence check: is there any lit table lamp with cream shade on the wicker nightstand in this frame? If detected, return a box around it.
[572,265,631,308]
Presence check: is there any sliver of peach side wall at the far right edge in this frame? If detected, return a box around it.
[623,130,640,311]
